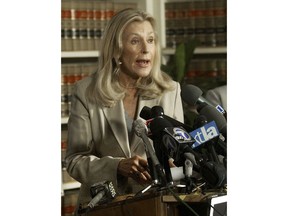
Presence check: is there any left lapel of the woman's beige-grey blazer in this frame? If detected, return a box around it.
[103,101,131,157]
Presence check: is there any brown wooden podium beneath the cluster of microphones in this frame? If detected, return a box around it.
[83,192,224,216]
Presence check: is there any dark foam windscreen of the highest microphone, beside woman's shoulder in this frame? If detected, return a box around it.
[181,85,203,106]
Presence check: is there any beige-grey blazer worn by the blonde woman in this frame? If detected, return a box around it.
[65,77,184,208]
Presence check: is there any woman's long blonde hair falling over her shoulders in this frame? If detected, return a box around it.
[87,8,175,107]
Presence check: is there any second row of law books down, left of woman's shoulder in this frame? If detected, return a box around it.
[61,63,97,117]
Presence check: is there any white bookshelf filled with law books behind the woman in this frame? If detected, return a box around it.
[61,0,227,215]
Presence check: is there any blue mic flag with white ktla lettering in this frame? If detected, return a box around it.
[189,121,219,148]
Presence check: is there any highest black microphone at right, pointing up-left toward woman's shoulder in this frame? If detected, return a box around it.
[181,84,227,119]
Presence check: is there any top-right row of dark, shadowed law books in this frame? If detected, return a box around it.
[165,0,227,48]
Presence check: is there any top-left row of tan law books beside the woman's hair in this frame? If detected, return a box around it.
[61,0,137,51]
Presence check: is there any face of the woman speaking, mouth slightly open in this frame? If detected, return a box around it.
[121,21,156,79]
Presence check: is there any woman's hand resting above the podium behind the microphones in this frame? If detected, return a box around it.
[118,155,151,184]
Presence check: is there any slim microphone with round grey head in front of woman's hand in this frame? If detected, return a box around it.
[133,119,164,184]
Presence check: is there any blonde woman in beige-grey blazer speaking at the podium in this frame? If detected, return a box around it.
[66,9,183,209]
